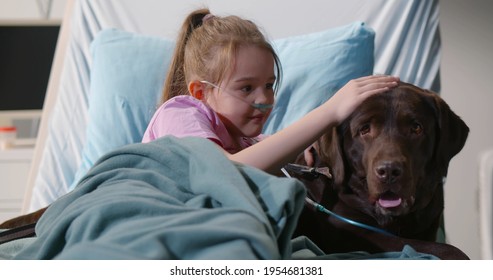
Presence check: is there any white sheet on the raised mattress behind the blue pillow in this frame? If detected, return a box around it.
[23,0,441,212]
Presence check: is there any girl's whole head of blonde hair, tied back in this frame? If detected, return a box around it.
[162,9,282,102]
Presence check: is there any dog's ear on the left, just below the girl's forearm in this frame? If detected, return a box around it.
[319,128,344,185]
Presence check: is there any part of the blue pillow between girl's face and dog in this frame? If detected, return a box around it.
[263,22,375,134]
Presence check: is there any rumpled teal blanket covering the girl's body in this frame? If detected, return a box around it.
[16,137,305,259]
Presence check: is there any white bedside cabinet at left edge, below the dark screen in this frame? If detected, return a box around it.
[0,147,34,223]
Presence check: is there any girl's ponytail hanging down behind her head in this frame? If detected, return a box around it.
[161,9,210,102]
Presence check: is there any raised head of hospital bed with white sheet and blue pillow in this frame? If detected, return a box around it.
[3,0,441,260]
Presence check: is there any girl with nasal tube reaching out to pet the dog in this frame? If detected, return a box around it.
[143,9,398,174]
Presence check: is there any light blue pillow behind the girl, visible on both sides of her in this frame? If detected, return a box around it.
[69,22,374,190]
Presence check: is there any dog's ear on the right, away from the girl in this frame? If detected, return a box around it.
[426,91,469,176]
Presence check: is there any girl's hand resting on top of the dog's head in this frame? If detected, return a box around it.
[328,75,399,123]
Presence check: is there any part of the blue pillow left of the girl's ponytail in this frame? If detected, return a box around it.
[69,29,175,190]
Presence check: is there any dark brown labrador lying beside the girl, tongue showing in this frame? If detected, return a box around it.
[287,83,469,259]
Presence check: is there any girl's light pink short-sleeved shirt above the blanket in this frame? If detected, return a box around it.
[142,95,264,153]
